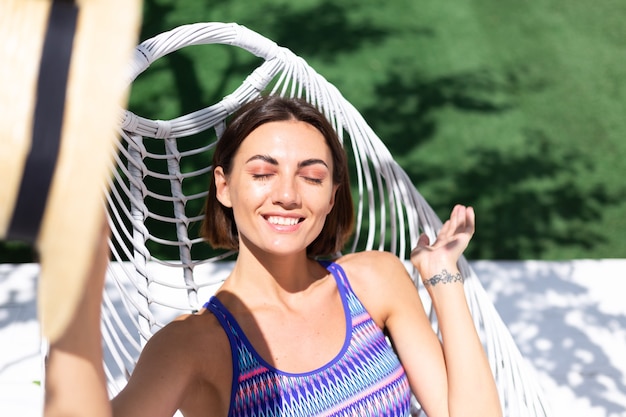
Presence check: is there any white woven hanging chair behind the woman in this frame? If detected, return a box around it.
[102,23,548,417]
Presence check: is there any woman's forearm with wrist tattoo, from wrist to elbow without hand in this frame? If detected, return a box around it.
[424,267,501,417]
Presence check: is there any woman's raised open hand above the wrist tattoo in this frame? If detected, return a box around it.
[411,204,475,275]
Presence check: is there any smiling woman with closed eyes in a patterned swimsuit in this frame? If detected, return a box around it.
[46,97,501,417]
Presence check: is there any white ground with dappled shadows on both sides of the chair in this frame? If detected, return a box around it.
[0,260,626,417]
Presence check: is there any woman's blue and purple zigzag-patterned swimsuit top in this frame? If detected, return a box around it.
[205,263,411,417]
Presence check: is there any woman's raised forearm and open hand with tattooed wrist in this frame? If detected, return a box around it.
[411,205,501,417]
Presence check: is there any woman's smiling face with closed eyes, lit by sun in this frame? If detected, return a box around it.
[214,120,337,254]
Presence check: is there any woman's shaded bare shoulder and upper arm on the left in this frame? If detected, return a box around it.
[112,311,232,415]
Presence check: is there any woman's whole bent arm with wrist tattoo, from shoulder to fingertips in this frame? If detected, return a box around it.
[354,206,501,417]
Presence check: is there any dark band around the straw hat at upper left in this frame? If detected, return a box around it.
[7,0,78,243]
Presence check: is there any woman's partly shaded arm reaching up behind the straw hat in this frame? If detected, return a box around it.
[44,219,202,417]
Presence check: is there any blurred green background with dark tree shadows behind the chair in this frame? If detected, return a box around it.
[0,0,626,262]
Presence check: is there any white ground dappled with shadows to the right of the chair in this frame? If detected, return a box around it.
[472,260,626,417]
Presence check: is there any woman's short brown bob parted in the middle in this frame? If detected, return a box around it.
[202,96,354,257]
